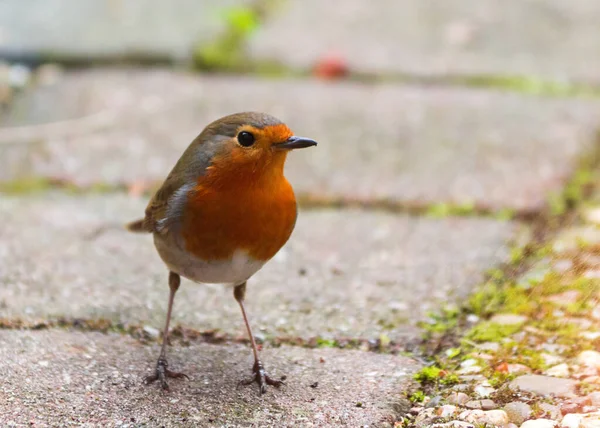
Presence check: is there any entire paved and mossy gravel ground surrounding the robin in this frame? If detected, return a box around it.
[0,0,600,427]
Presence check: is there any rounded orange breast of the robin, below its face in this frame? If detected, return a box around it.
[182,161,297,261]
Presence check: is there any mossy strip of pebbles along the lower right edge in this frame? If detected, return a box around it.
[398,150,600,427]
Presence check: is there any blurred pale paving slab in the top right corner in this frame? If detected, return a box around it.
[249,0,600,83]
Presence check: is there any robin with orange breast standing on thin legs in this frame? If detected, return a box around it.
[126,112,317,395]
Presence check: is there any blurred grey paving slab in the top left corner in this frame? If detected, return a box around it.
[0,0,249,61]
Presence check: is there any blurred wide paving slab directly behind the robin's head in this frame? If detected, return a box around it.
[0,70,600,210]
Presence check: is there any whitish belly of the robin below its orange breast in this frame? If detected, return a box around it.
[154,234,265,285]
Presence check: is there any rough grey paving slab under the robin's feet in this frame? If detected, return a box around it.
[0,331,418,427]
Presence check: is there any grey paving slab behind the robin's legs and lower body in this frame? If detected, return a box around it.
[0,193,518,343]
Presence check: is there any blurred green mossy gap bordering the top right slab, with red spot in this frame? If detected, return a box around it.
[186,0,600,97]
